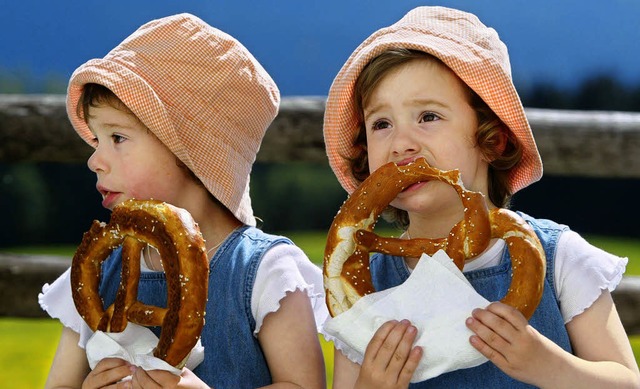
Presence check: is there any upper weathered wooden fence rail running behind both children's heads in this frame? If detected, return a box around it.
[0,95,640,178]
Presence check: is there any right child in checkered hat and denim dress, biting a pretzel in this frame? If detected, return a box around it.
[324,7,640,388]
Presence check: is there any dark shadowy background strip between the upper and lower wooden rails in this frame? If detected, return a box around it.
[0,163,640,247]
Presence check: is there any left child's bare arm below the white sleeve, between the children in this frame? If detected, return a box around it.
[258,290,326,389]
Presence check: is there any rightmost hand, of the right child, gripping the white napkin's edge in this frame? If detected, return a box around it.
[466,302,558,384]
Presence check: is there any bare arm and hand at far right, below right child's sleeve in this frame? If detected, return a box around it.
[467,290,640,388]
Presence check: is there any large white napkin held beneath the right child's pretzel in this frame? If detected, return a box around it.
[324,250,489,382]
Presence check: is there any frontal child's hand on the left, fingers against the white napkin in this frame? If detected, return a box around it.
[355,320,422,388]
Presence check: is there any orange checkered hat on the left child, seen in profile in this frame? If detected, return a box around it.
[67,13,280,225]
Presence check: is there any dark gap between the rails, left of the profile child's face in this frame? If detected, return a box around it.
[0,163,109,247]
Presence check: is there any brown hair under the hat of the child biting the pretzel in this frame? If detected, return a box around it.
[349,49,522,228]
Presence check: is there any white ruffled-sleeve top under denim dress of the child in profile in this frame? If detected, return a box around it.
[38,243,329,348]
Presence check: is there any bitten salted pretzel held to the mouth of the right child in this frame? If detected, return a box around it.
[323,158,546,319]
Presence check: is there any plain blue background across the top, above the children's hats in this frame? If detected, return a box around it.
[0,0,640,96]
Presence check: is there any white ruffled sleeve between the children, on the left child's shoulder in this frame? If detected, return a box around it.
[251,244,329,336]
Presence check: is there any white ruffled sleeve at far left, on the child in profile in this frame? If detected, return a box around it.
[38,268,93,348]
